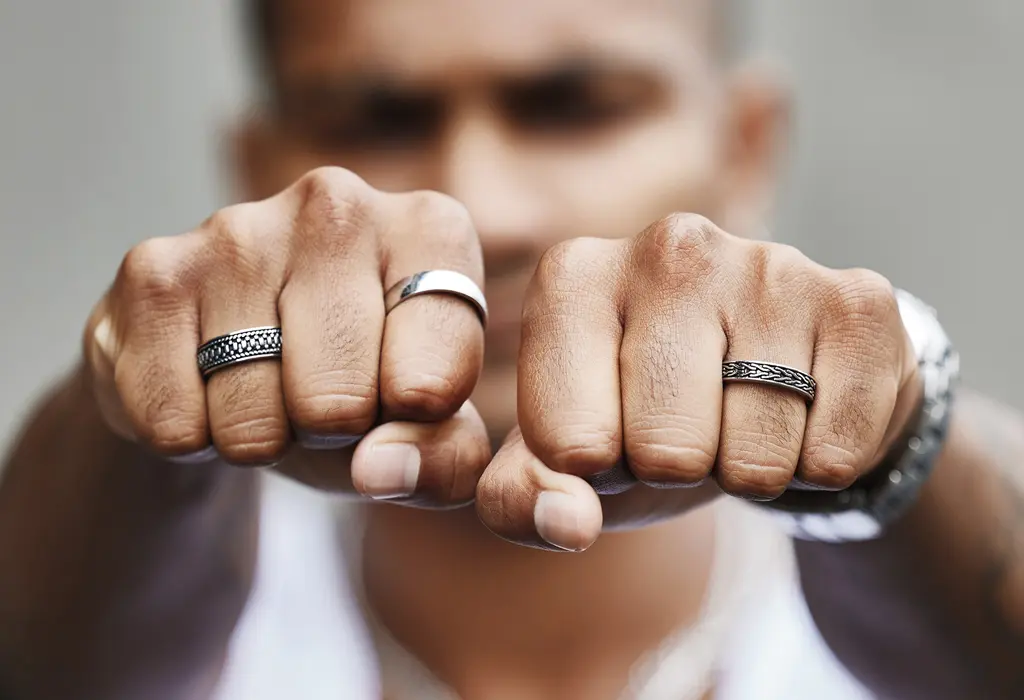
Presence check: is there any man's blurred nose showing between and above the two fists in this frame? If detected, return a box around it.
[439,108,552,276]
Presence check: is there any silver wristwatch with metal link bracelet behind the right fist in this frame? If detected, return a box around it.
[766,290,959,542]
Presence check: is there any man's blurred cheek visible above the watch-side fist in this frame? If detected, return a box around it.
[544,119,722,237]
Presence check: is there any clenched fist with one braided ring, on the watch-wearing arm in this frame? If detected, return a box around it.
[477,215,921,550]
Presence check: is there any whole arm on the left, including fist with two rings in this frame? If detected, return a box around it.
[0,168,490,700]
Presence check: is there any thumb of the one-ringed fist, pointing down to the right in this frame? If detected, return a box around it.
[476,430,602,552]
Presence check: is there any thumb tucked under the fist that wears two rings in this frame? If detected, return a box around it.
[351,402,490,508]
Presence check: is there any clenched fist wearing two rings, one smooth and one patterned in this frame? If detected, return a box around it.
[85,168,490,507]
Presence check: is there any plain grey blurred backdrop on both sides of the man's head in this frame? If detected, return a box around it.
[0,0,1024,444]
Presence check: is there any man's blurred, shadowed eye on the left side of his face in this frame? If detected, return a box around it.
[284,88,444,150]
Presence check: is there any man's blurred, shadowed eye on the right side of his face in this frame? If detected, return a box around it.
[502,71,649,134]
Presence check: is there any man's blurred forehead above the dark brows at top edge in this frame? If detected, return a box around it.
[275,0,716,81]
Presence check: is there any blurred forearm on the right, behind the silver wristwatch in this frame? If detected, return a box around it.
[797,395,1024,700]
